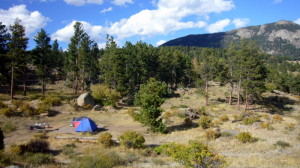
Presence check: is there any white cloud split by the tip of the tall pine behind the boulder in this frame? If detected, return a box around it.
[51,21,107,42]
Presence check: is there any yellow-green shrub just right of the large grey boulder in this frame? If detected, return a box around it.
[91,84,121,106]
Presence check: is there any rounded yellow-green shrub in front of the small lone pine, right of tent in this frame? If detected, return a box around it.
[119,131,145,148]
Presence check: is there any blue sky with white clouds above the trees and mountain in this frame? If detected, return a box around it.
[0,0,300,49]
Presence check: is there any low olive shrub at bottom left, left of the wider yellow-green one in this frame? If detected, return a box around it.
[25,153,55,166]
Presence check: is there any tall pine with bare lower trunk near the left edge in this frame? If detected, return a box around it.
[8,19,28,99]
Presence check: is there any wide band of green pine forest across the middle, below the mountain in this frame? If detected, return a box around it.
[0,20,300,102]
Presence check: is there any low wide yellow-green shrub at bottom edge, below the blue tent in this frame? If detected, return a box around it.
[69,153,126,168]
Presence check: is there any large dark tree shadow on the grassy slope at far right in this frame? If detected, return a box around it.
[259,96,296,115]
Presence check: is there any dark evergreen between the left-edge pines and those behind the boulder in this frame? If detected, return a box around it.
[32,29,54,94]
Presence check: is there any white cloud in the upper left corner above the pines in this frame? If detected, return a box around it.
[0,5,50,35]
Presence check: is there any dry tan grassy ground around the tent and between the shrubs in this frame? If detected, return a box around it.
[0,86,300,168]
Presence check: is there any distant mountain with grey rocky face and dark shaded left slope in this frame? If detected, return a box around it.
[162,20,300,59]
